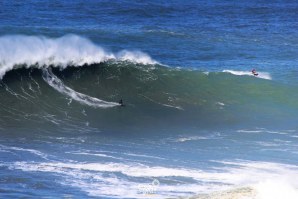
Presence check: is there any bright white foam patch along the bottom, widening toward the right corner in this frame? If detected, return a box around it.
[8,160,298,199]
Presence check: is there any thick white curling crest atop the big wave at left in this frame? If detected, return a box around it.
[0,35,158,78]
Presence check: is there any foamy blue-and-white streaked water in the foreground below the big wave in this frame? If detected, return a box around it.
[0,126,298,199]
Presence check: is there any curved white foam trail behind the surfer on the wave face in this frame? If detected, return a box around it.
[42,68,119,108]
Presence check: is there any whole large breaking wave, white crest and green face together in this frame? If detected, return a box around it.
[0,35,298,126]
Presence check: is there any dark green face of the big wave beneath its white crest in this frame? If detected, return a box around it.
[0,54,298,129]
